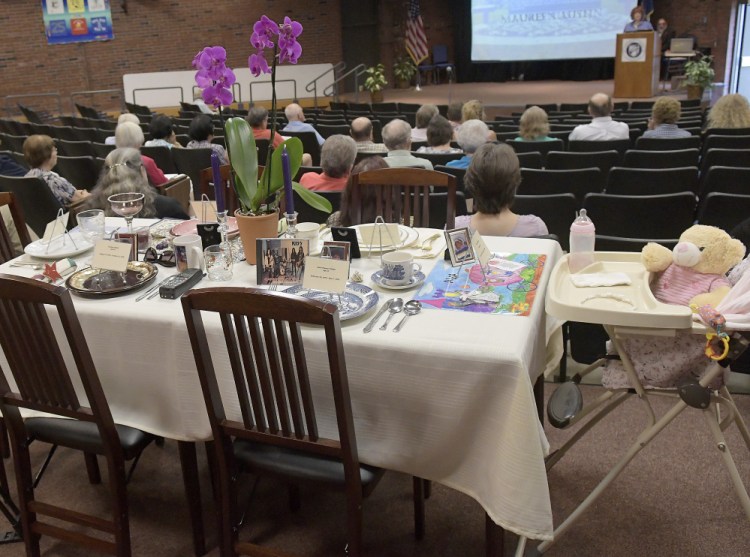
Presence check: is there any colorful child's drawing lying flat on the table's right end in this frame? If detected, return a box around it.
[414,253,547,316]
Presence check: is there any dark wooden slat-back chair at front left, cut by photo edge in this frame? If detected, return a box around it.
[0,274,153,557]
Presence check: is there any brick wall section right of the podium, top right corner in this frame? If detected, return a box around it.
[651,0,734,82]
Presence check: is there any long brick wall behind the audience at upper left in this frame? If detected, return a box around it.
[0,0,342,112]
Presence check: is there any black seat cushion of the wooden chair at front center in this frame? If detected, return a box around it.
[234,439,384,491]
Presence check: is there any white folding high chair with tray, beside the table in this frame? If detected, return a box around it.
[516,252,750,557]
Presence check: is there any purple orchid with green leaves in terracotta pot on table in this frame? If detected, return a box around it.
[193,16,331,265]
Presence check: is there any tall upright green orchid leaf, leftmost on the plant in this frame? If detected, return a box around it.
[224,118,260,213]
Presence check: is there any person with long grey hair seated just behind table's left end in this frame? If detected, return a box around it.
[84,147,190,219]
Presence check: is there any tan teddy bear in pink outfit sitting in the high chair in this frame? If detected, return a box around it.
[641,224,745,307]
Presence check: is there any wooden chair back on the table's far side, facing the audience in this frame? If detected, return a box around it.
[351,168,456,229]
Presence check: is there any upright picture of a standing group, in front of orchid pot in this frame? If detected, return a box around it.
[256,238,310,285]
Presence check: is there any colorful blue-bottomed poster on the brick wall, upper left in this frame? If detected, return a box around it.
[42,0,114,44]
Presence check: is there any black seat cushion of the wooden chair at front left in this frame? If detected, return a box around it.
[24,418,155,460]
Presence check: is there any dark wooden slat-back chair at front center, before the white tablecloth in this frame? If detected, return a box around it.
[182,288,424,557]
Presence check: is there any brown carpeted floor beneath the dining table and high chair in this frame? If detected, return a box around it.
[0,384,750,557]
